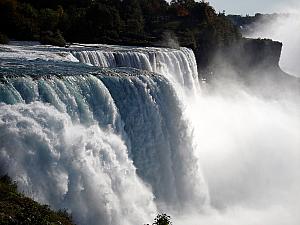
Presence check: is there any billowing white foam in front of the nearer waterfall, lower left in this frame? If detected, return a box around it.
[0,102,156,225]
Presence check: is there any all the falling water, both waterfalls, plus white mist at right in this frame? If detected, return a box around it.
[0,43,300,225]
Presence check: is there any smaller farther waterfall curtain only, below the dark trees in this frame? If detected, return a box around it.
[72,46,199,95]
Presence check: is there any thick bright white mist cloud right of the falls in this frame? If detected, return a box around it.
[179,86,300,225]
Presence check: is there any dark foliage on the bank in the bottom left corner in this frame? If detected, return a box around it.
[0,175,73,225]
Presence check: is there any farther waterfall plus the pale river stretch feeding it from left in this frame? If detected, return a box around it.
[0,42,200,95]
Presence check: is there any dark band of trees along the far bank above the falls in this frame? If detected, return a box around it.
[0,0,241,67]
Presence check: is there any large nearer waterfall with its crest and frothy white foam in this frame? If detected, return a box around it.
[0,55,208,225]
